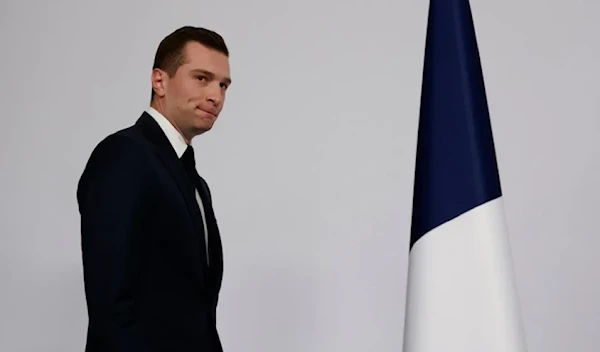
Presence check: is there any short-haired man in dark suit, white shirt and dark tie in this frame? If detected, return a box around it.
[77,27,231,352]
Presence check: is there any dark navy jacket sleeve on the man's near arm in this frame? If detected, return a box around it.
[77,135,151,352]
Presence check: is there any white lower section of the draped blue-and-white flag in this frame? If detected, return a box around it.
[404,198,526,352]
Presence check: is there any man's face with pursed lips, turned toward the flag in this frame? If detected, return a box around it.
[153,42,231,141]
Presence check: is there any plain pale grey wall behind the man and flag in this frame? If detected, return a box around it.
[0,0,600,352]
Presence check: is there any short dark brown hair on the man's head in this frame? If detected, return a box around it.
[150,26,229,100]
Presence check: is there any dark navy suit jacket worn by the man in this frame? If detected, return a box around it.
[77,113,223,352]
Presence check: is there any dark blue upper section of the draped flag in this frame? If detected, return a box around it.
[410,0,502,248]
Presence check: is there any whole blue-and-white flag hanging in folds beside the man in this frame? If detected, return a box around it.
[403,0,526,352]
